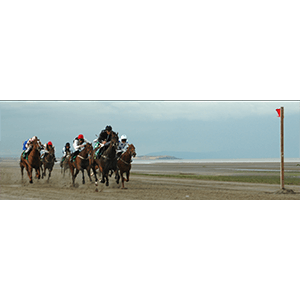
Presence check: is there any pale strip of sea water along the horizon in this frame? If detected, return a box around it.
[132,158,300,164]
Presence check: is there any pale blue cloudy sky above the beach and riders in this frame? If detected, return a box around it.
[0,100,300,159]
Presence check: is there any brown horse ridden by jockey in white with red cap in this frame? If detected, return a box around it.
[68,143,93,186]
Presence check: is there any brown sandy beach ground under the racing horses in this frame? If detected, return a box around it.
[0,159,300,200]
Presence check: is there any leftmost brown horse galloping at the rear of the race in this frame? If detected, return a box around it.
[20,139,42,183]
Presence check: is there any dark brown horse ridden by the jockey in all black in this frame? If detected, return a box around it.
[91,133,120,186]
